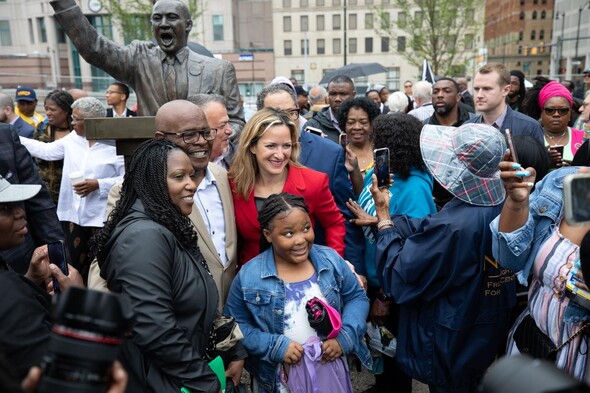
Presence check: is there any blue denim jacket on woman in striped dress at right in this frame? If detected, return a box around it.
[490,167,579,285]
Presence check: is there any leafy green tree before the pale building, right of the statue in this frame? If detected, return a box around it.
[373,0,484,76]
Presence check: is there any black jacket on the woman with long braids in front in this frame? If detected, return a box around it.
[99,200,220,393]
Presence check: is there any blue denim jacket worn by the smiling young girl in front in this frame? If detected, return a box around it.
[225,244,371,392]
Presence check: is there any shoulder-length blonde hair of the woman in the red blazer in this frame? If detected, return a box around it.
[229,108,301,200]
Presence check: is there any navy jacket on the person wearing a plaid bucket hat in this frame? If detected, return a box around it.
[376,198,516,388]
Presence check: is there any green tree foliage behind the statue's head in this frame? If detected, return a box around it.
[103,0,203,44]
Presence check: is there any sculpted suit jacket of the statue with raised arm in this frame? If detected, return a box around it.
[51,0,244,128]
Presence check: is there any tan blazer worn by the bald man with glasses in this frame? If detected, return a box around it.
[88,163,238,312]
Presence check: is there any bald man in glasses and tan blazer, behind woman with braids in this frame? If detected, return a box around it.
[88,100,237,311]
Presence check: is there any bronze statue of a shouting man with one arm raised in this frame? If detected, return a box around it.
[50,0,244,129]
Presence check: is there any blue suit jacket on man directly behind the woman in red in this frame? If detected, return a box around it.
[299,131,365,275]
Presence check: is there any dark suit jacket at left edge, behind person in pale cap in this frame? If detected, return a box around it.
[0,123,64,274]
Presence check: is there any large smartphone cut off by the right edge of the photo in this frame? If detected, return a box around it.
[563,173,590,225]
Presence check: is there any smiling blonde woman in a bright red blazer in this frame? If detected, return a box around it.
[229,108,346,266]
